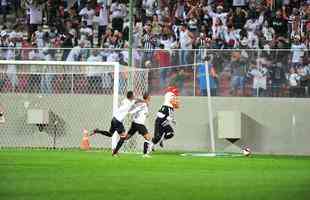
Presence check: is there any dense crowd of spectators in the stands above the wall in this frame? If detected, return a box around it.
[0,0,310,96]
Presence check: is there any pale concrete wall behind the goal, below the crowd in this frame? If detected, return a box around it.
[0,94,310,155]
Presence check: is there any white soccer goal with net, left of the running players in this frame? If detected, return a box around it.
[0,60,148,151]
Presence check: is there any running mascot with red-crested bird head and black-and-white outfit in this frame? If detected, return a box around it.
[152,87,179,147]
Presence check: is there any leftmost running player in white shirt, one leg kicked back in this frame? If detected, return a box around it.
[89,91,136,145]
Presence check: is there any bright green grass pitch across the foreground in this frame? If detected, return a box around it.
[0,150,310,200]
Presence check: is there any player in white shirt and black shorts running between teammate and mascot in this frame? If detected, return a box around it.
[113,93,152,157]
